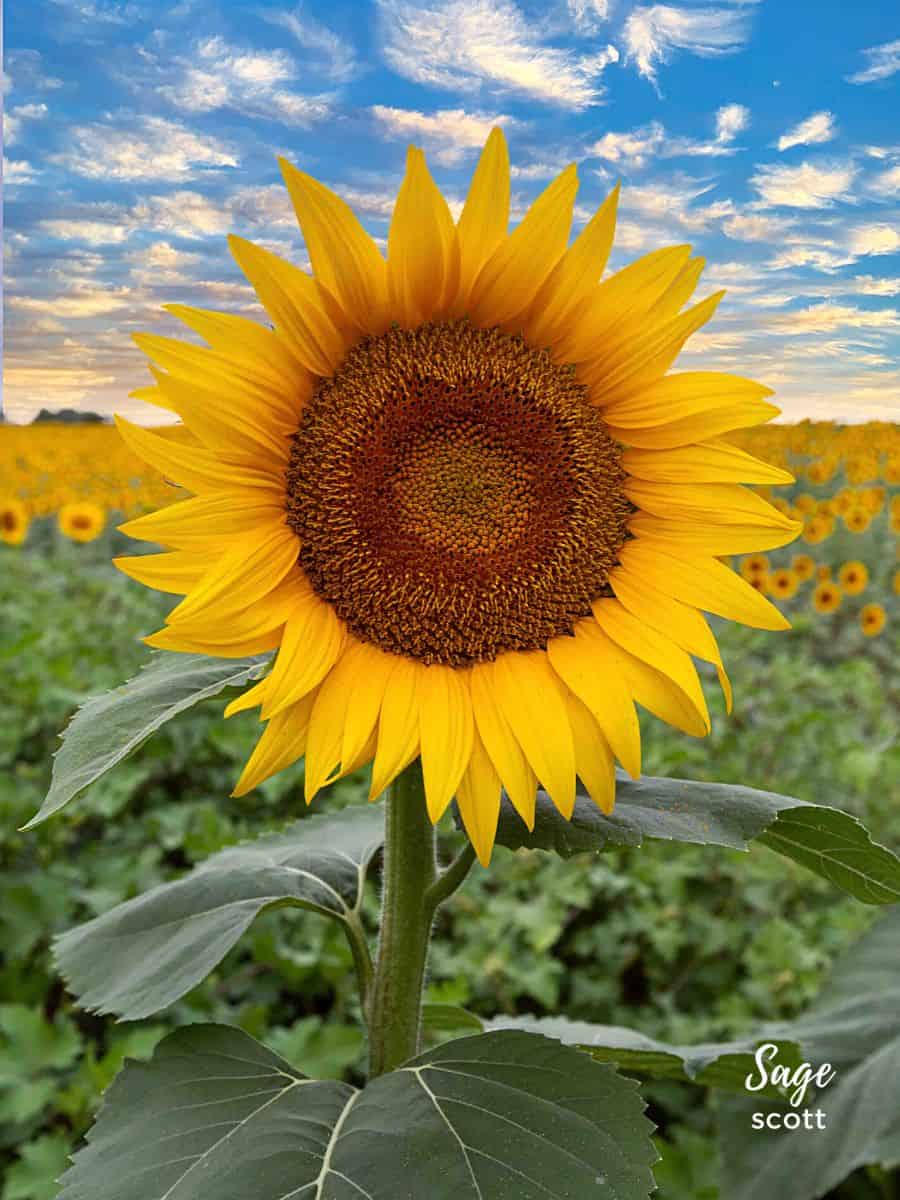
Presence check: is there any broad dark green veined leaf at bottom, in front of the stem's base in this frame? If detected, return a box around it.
[59,1025,656,1200]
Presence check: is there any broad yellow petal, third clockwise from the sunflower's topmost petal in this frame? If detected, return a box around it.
[553,246,691,362]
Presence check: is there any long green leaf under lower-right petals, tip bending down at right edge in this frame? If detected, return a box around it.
[497,776,900,904]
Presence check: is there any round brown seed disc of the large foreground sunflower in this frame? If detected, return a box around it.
[287,322,631,666]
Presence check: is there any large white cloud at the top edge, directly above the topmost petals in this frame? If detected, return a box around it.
[378,0,619,112]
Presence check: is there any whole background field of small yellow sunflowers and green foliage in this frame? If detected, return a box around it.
[0,422,900,1200]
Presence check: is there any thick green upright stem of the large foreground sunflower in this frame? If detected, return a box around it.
[368,761,437,1079]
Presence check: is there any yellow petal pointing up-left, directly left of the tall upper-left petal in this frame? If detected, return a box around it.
[228,235,349,376]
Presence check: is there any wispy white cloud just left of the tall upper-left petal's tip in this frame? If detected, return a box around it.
[53,116,238,181]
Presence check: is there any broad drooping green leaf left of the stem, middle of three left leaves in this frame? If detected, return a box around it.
[54,805,384,1020]
